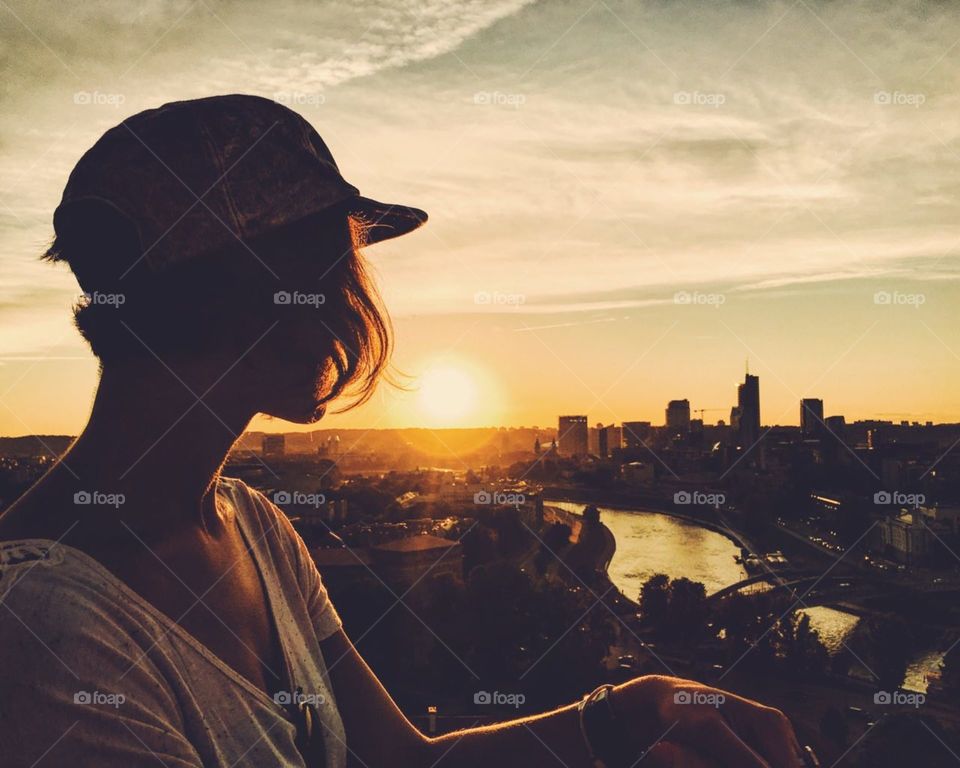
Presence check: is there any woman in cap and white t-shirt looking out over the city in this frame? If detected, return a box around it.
[0,96,802,768]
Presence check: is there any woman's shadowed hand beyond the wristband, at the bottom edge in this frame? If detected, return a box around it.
[613,676,803,768]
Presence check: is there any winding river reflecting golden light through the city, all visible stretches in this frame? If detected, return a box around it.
[547,501,943,692]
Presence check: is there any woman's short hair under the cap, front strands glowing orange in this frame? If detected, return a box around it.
[43,206,392,410]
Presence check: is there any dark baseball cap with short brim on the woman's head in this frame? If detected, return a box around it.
[53,94,427,280]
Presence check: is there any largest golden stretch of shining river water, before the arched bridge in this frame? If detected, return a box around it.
[549,501,747,600]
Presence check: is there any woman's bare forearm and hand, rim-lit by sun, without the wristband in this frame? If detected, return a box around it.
[322,631,802,768]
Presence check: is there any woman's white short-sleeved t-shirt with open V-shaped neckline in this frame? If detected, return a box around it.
[0,478,346,768]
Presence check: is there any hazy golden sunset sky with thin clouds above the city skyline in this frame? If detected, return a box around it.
[0,0,960,435]
